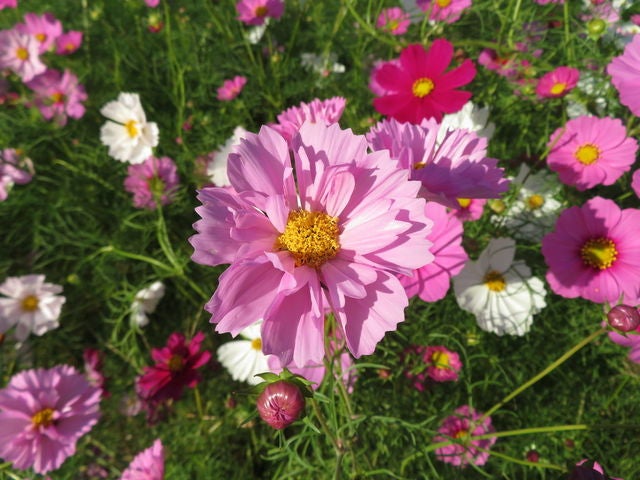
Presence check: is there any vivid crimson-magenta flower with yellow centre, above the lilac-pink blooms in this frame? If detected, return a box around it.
[373,39,476,123]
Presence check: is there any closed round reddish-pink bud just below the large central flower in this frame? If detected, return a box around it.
[257,380,305,430]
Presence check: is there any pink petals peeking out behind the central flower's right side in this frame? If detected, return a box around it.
[399,202,469,302]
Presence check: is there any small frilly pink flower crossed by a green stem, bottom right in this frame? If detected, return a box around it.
[433,405,497,468]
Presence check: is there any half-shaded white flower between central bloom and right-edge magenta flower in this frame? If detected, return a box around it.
[453,238,546,336]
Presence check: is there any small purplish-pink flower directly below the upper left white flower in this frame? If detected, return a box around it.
[124,157,180,210]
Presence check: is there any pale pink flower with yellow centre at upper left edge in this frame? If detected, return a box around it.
[0,29,47,82]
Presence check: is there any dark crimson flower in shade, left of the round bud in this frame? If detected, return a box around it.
[136,332,211,403]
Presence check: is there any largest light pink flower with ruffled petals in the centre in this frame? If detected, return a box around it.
[190,123,432,366]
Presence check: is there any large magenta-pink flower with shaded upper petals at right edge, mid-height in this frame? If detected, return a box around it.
[542,197,640,303]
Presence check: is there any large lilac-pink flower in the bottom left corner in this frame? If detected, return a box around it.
[0,365,100,473]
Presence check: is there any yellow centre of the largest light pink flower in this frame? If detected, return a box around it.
[274,210,340,268]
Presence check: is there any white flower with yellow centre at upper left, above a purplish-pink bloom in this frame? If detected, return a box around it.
[100,93,160,163]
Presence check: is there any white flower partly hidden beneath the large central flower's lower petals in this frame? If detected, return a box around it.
[218,320,270,385]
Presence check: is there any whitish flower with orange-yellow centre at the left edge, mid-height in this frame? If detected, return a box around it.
[0,275,66,342]
